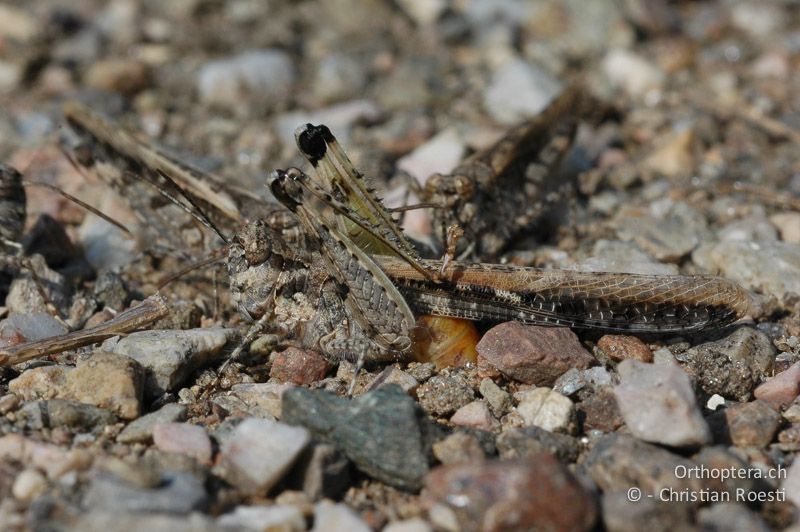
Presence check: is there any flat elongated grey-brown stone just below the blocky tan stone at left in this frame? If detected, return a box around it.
[17,399,117,432]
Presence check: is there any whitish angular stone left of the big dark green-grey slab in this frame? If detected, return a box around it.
[215,418,310,495]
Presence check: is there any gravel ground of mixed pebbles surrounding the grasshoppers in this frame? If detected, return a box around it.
[0,0,800,532]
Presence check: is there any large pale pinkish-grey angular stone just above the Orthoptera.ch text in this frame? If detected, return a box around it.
[614,360,711,447]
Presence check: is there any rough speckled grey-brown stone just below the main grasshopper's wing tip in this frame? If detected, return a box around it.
[677,327,775,401]
